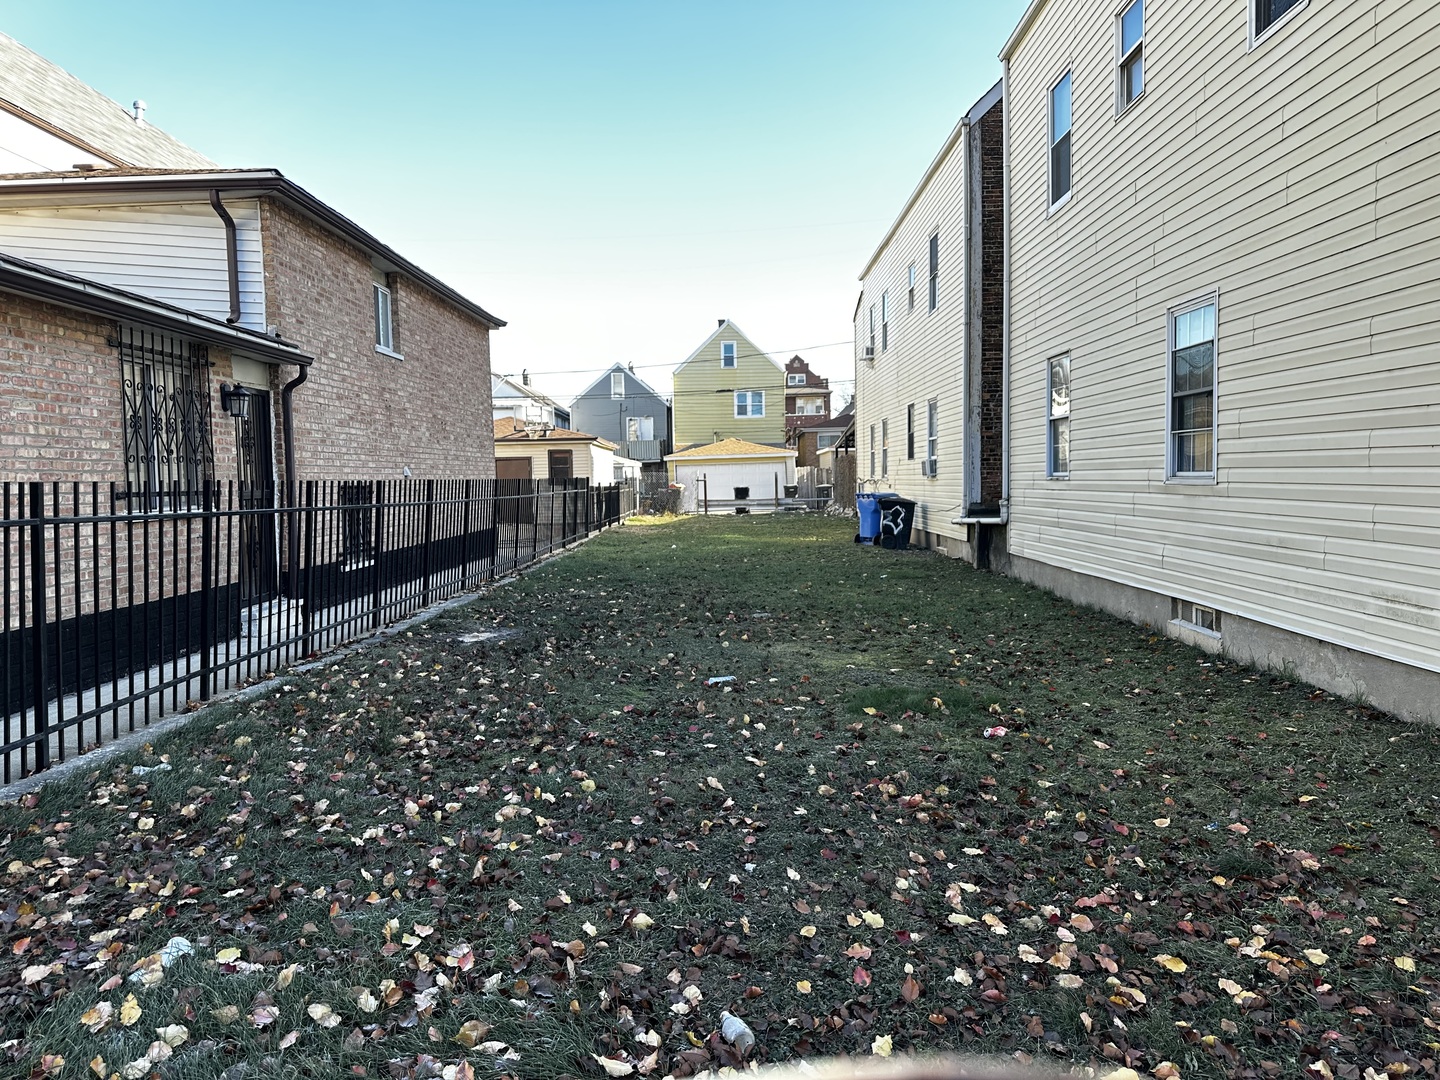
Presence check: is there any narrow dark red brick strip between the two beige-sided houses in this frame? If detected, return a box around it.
[978,101,1005,505]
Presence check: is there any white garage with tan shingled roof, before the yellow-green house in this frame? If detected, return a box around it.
[665,439,795,514]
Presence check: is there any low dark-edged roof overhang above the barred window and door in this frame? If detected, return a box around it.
[0,255,314,367]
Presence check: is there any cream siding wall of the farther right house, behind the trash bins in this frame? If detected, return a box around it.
[855,126,968,543]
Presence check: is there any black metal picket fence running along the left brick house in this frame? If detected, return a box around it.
[0,480,635,783]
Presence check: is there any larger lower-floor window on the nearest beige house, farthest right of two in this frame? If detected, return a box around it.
[1168,297,1215,477]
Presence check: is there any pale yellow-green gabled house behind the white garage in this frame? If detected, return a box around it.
[672,318,785,449]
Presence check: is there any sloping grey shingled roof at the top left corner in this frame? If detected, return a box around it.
[0,33,215,168]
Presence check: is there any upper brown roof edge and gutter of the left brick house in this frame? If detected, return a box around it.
[0,168,505,328]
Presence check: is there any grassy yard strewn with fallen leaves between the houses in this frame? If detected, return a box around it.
[0,517,1440,1080]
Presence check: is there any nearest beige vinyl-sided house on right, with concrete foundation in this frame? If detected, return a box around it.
[1002,0,1440,720]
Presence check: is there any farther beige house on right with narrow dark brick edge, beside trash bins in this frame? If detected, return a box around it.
[855,85,1004,562]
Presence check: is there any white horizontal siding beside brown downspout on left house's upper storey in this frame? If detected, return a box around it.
[0,200,265,331]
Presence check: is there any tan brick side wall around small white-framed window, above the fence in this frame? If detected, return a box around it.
[261,199,495,480]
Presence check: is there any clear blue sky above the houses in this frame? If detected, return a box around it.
[0,0,1025,399]
